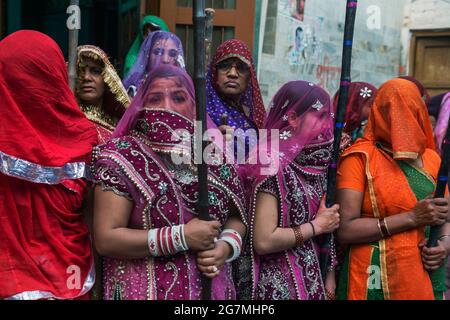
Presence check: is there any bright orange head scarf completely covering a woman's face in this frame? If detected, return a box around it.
[363,79,435,160]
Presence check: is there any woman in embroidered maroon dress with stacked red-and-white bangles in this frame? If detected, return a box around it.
[94,65,246,300]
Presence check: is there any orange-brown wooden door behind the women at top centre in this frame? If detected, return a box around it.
[160,0,256,74]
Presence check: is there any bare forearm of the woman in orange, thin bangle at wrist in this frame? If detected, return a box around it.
[338,212,417,244]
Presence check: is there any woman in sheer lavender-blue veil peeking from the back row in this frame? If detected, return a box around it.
[123,31,185,98]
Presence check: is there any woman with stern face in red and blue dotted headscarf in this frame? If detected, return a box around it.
[206,39,266,164]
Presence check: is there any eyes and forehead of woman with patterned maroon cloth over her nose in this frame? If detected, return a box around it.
[144,77,195,120]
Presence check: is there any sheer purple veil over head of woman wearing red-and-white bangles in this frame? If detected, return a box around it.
[112,64,195,138]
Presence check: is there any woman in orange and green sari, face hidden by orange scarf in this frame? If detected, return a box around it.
[337,79,450,300]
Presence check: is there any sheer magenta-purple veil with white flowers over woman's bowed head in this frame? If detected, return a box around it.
[240,81,333,183]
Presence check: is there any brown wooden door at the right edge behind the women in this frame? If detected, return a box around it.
[410,31,450,96]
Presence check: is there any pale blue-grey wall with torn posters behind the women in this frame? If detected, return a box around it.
[259,0,407,105]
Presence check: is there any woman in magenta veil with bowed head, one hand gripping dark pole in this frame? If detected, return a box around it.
[244,81,339,300]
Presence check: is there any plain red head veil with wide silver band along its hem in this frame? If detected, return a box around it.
[0,31,97,180]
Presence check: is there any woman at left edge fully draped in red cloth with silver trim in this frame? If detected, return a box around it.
[0,31,97,299]
